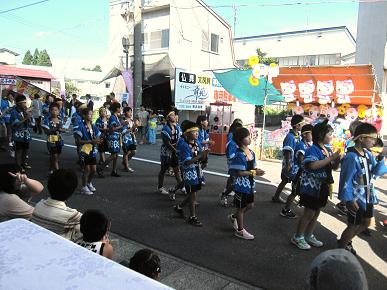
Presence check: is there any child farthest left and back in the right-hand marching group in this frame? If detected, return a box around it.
[272,115,304,203]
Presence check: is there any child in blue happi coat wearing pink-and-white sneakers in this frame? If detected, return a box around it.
[228,128,265,240]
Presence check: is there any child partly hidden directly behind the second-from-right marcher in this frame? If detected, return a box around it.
[280,124,313,218]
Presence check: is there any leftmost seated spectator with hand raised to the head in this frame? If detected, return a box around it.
[0,163,44,222]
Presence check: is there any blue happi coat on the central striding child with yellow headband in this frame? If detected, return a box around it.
[177,138,203,186]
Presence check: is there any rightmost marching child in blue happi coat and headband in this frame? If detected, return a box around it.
[338,123,387,254]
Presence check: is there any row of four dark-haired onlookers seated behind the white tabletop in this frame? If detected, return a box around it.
[0,163,161,280]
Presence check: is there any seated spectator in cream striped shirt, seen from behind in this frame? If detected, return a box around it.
[31,169,82,241]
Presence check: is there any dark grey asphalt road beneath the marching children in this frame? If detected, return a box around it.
[0,138,387,289]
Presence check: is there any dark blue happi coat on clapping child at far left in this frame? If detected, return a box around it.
[10,106,34,143]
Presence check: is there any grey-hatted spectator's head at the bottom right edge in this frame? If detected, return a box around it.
[304,249,368,290]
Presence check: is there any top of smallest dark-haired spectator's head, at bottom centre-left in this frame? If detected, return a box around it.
[129,249,161,280]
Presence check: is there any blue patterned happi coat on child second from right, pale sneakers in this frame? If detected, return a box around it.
[300,144,333,198]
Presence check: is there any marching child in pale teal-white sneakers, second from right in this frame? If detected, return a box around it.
[291,120,340,250]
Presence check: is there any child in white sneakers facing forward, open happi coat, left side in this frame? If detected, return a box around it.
[75,108,101,195]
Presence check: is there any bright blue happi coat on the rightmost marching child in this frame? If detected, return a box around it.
[339,147,387,210]
